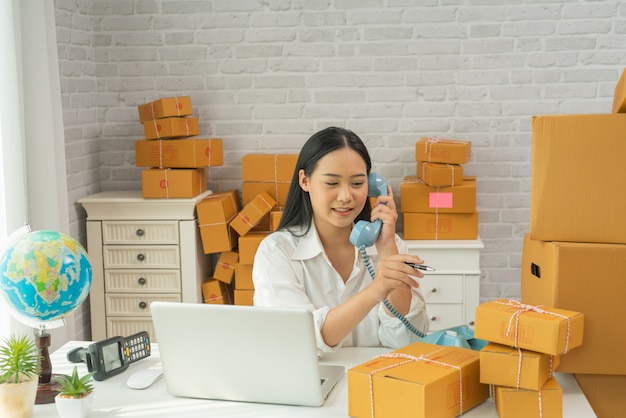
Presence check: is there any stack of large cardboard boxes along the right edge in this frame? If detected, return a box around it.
[522,67,626,418]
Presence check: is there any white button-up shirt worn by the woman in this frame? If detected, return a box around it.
[252,224,428,355]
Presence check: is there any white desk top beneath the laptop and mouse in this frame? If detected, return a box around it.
[33,341,595,418]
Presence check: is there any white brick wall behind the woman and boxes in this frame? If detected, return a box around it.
[55,0,626,334]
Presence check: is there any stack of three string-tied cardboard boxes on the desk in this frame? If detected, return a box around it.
[474,299,585,418]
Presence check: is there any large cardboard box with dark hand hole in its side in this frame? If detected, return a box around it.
[522,234,626,375]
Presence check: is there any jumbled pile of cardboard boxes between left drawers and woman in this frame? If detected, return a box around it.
[196,154,298,305]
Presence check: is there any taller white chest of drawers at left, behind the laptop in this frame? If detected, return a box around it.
[78,191,211,342]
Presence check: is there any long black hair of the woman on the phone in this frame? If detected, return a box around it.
[278,127,372,234]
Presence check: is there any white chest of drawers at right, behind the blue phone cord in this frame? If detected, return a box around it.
[406,238,484,331]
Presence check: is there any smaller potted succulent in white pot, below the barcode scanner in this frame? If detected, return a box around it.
[53,366,94,418]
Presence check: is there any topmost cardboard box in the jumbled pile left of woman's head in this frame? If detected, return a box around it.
[241,154,298,183]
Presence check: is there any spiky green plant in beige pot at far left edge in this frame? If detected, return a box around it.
[0,335,41,418]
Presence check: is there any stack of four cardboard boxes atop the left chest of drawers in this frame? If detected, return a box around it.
[135,96,224,199]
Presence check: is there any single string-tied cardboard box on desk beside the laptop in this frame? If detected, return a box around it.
[348,342,489,418]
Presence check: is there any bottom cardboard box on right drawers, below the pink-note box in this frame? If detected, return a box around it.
[402,212,478,240]
